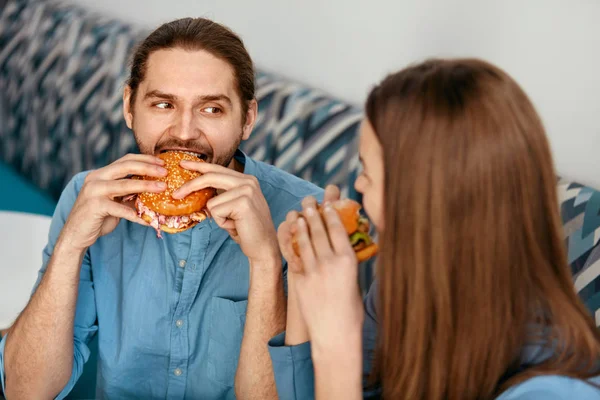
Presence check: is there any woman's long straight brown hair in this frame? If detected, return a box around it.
[366,59,600,400]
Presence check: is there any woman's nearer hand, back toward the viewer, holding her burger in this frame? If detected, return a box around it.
[292,197,364,356]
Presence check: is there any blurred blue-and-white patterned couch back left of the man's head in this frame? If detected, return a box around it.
[0,1,141,199]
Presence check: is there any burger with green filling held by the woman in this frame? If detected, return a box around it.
[292,199,379,262]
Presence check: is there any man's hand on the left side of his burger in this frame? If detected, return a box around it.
[61,154,167,251]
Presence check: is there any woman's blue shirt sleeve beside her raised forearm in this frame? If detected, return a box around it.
[269,283,377,400]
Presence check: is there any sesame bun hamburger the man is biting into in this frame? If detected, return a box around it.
[135,151,216,238]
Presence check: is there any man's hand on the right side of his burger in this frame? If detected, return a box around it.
[173,161,280,265]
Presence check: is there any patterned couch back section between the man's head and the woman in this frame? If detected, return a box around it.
[242,72,362,200]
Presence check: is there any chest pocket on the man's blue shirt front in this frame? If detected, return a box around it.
[208,297,248,387]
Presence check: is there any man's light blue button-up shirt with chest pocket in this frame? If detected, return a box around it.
[0,152,322,399]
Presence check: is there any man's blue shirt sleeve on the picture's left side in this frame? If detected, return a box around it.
[0,173,98,399]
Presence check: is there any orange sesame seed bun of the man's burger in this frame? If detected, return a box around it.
[139,151,216,216]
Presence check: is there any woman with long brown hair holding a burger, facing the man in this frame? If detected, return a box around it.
[270,60,600,400]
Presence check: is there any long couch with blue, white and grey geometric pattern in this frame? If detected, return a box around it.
[0,0,600,398]
